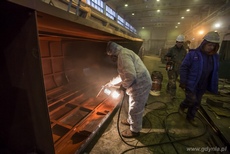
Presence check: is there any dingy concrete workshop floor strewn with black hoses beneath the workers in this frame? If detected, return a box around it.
[84,56,230,154]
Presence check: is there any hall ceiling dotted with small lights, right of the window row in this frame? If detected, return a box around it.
[103,0,230,32]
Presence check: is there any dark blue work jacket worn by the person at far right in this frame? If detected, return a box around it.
[180,42,219,93]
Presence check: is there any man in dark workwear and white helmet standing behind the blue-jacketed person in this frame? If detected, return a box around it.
[166,35,187,98]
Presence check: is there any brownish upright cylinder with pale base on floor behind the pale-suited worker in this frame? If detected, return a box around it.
[150,71,163,96]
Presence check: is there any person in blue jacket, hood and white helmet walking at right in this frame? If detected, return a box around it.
[178,32,220,127]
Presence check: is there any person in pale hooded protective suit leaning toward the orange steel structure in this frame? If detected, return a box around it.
[107,42,152,138]
